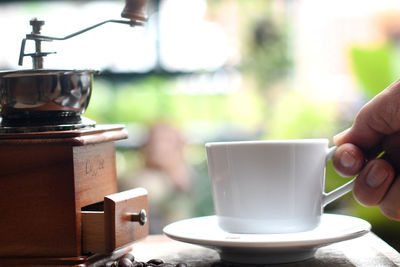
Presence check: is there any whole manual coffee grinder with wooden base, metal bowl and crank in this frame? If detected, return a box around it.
[0,0,148,266]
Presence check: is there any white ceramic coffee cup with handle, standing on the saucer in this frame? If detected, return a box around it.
[206,139,354,234]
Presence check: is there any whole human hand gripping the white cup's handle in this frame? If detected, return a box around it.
[333,80,400,221]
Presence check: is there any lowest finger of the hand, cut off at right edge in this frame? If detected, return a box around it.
[379,177,400,221]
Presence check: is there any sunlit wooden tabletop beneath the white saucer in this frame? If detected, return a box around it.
[131,233,400,267]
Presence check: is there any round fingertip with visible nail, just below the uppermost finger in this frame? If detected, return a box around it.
[332,144,364,177]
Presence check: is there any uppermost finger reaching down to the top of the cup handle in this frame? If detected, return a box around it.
[334,80,400,150]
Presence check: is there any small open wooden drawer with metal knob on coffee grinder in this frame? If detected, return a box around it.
[81,188,149,254]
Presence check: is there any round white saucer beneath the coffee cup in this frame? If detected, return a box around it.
[163,214,371,264]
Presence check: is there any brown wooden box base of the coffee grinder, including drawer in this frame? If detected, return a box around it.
[0,125,148,266]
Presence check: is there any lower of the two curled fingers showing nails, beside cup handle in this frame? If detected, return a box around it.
[353,159,394,206]
